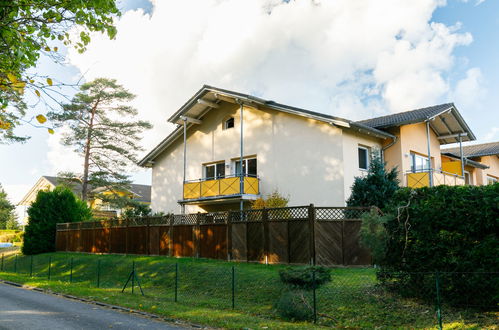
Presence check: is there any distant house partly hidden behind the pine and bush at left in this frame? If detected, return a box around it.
[18,176,151,221]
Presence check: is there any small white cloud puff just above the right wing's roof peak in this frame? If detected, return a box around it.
[453,68,486,107]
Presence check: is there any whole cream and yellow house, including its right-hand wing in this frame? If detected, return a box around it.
[139,85,499,213]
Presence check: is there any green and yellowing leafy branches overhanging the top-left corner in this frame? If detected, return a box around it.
[0,0,120,142]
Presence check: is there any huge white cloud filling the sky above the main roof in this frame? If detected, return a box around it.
[66,0,472,148]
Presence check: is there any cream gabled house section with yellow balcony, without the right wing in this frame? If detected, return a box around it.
[139,86,394,213]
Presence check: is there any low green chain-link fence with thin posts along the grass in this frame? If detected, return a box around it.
[0,253,499,328]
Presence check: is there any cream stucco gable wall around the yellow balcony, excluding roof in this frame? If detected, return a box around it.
[151,102,381,213]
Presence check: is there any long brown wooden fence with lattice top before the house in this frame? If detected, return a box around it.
[56,205,371,266]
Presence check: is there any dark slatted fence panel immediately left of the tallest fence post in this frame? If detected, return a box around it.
[288,221,311,264]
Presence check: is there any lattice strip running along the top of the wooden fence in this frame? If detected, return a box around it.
[57,206,377,231]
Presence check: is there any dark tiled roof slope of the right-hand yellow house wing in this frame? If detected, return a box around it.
[358,103,454,129]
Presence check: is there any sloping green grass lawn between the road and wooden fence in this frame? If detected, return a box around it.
[0,249,499,329]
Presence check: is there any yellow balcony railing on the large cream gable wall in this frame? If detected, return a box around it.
[184,175,260,200]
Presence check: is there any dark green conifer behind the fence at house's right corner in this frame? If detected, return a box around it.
[347,153,399,209]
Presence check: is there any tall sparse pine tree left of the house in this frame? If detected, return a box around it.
[49,78,152,201]
